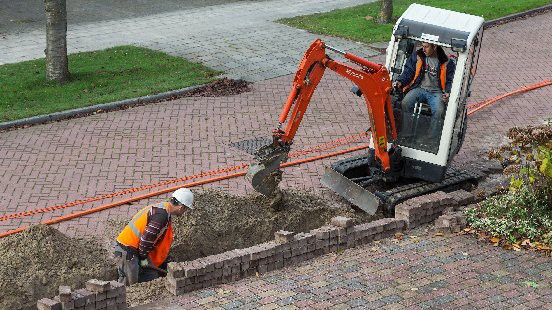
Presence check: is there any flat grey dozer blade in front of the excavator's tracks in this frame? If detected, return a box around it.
[320,167,380,215]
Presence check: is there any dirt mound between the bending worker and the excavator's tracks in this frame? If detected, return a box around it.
[171,190,369,261]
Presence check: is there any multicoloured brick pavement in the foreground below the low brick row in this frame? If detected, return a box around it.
[133,228,552,310]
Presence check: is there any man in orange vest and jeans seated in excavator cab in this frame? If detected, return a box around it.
[394,42,456,138]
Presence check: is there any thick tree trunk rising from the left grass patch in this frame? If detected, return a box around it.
[44,0,69,83]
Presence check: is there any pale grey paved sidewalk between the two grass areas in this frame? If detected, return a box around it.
[0,0,377,81]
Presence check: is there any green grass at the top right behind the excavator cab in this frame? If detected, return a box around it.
[278,0,552,43]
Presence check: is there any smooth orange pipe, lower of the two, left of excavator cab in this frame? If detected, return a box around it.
[0,145,368,238]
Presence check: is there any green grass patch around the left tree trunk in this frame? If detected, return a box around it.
[0,46,219,122]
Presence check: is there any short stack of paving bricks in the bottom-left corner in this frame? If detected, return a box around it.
[37,279,128,310]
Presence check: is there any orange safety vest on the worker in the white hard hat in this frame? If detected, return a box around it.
[117,202,173,267]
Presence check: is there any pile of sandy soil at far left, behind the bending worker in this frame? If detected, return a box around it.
[0,224,116,309]
